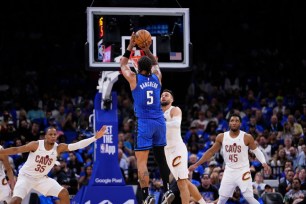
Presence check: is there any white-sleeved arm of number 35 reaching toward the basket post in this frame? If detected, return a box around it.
[57,125,106,154]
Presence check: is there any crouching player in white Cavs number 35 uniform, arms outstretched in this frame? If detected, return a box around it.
[0,126,106,204]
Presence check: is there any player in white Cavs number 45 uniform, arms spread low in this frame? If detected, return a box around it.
[189,114,270,204]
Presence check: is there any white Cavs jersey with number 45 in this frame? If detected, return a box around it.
[222,130,250,169]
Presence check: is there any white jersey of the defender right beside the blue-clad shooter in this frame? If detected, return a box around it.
[164,106,184,147]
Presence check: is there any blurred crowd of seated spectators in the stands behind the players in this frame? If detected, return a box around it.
[0,64,306,203]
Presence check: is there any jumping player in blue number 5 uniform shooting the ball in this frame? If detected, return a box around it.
[120,33,174,204]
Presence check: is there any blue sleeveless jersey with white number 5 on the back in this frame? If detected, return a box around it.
[132,74,163,118]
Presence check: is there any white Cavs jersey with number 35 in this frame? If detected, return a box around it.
[19,140,58,178]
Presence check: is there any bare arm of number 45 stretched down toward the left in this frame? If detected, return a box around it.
[188,133,223,171]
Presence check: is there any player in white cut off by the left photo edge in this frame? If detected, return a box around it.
[0,145,16,203]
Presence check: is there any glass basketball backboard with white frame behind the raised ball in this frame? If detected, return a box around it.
[86,7,191,71]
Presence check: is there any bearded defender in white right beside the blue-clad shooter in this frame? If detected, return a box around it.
[161,89,205,204]
